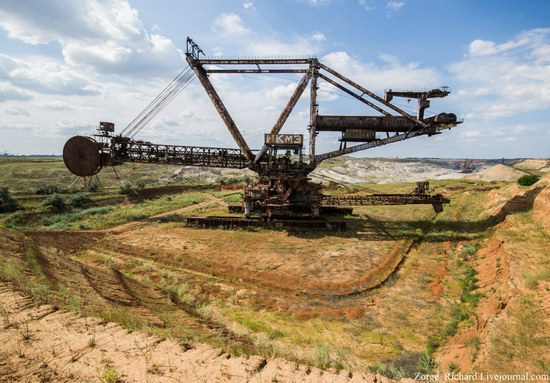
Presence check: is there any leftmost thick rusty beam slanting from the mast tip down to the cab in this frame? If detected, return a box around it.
[187,54,254,161]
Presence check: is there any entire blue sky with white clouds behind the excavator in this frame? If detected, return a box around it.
[0,0,550,158]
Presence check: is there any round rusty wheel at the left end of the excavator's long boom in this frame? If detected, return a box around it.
[63,136,102,177]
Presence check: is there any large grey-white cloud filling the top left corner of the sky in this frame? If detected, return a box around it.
[0,0,183,75]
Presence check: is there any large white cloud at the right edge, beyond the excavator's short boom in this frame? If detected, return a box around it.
[449,28,550,121]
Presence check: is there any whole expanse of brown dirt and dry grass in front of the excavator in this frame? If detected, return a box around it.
[0,177,550,382]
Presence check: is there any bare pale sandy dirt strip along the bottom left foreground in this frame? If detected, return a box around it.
[0,283,390,383]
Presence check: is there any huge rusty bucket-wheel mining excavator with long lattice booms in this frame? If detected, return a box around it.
[63,38,461,230]
